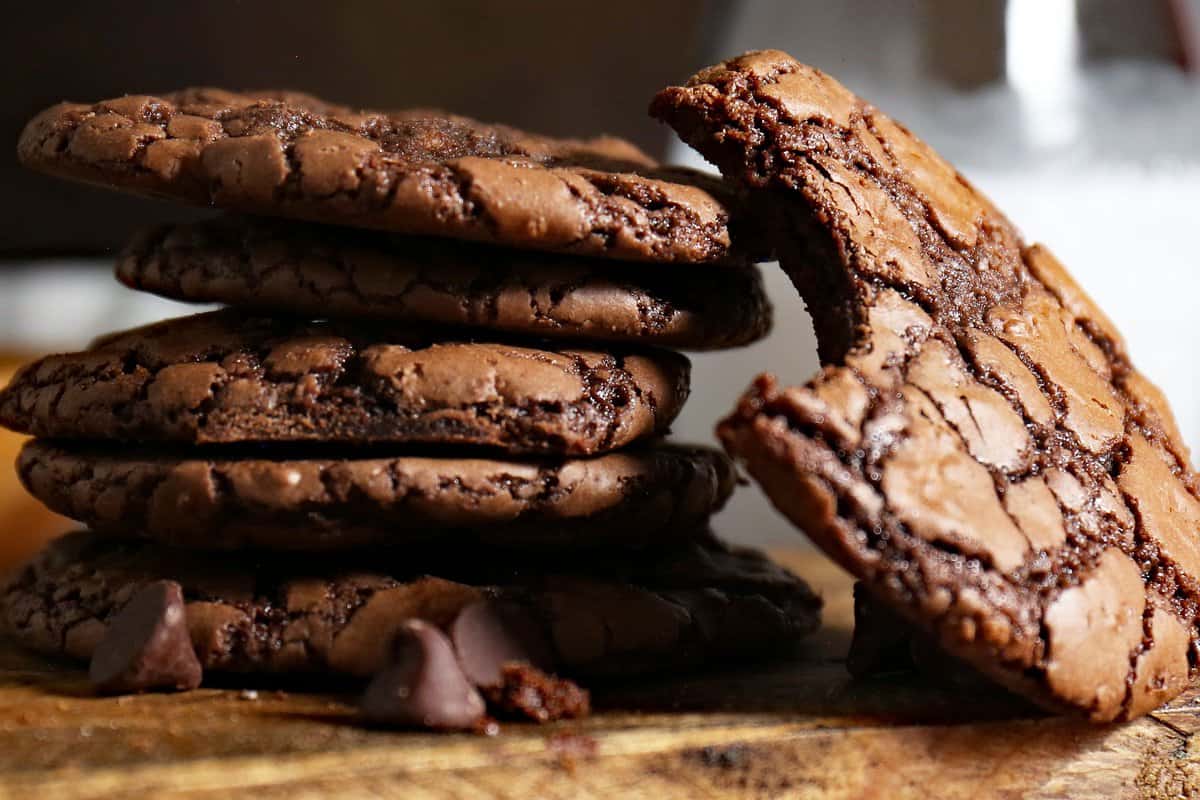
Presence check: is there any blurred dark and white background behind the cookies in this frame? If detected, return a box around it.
[0,0,1200,566]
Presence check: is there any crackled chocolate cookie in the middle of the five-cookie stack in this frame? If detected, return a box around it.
[0,309,689,455]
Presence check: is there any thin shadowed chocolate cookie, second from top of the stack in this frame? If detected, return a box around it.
[116,218,770,350]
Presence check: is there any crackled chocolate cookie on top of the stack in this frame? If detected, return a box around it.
[17,89,748,261]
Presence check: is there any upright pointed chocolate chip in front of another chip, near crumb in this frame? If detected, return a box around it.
[360,620,485,730]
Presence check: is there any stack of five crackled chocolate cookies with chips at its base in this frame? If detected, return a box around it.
[0,90,820,728]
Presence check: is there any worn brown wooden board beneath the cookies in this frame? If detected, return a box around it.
[0,553,1200,800]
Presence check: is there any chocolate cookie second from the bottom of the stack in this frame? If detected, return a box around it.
[18,440,737,551]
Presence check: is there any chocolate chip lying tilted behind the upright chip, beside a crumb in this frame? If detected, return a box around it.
[450,600,554,687]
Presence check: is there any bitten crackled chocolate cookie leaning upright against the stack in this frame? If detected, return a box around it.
[652,52,1200,721]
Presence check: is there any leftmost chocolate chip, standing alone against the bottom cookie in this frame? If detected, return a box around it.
[88,581,203,694]
